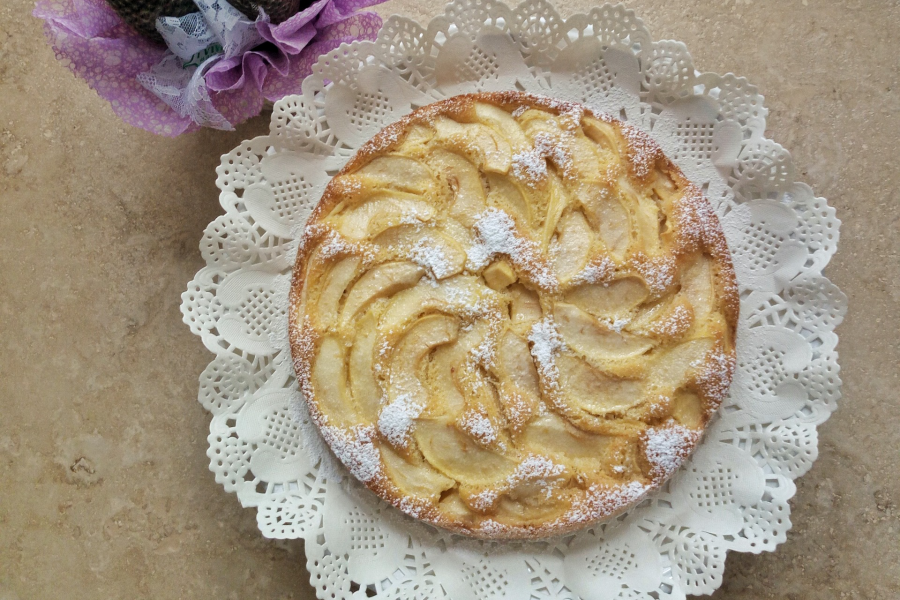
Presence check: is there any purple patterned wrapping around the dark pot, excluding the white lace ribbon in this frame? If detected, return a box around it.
[34,0,384,136]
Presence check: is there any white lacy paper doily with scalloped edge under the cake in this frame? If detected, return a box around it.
[182,0,846,600]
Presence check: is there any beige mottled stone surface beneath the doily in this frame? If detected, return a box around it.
[0,0,900,600]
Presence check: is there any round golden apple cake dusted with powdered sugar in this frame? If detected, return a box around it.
[289,92,738,539]
